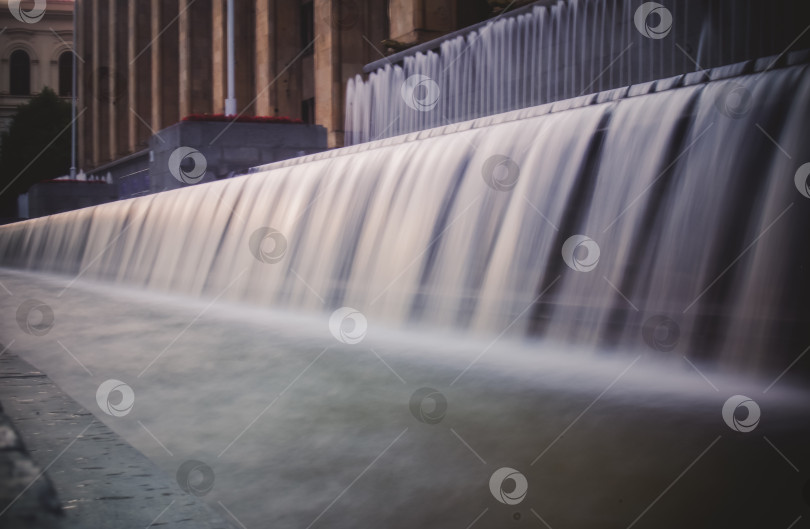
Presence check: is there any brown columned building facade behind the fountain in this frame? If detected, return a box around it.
[76,0,491,170]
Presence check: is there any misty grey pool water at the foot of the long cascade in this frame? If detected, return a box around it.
[0,270,810,529]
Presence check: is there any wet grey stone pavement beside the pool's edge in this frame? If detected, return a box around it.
[0,346,234,529]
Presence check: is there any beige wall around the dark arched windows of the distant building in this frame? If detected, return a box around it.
[0,0,73,136]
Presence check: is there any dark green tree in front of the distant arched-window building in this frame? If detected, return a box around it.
[0,88,71,198]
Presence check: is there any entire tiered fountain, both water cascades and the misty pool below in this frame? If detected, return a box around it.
[0,2,810,527]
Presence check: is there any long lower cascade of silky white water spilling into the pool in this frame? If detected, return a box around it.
[0,52,810,376]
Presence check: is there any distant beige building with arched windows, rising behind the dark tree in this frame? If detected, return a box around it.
[0,0,74,136]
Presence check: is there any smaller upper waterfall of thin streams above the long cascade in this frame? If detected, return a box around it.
[345,0,810,145]
